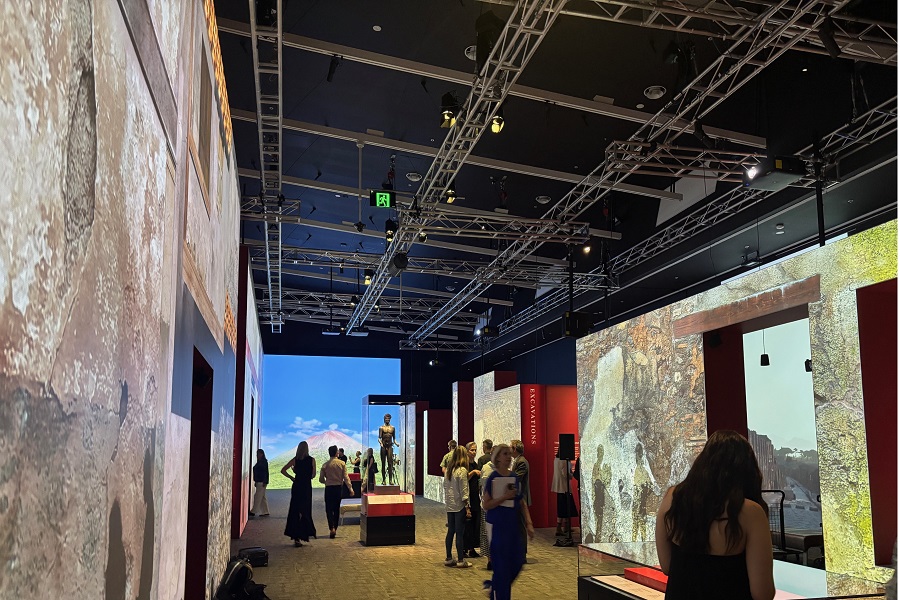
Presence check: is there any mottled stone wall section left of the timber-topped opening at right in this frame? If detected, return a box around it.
[577,307,706,543]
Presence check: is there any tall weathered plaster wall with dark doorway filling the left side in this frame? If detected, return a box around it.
[0,0,246,599]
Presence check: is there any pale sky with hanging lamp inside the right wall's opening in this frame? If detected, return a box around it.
[744,319,816,450]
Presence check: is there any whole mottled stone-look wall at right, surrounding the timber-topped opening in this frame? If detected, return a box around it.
[577,221,897,581]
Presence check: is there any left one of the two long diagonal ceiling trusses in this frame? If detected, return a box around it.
[347,0,566,330]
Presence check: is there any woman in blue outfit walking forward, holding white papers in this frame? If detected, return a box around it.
[481,444,534,600]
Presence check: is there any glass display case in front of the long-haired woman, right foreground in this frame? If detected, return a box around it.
[578,542,884,600]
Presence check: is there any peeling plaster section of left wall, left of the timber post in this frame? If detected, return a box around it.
[0,1,174,598]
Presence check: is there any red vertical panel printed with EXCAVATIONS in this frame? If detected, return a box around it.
[519,383,552,527]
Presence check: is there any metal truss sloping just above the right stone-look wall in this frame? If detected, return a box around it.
[498,96,897,335]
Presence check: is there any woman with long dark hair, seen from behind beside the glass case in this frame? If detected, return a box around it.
[656,430,775,600]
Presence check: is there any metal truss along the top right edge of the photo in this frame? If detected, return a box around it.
[481,0,897,66]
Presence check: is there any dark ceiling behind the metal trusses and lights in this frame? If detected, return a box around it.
[216,0,897,366]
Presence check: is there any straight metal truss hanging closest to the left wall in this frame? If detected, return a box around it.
[250,0,283,333]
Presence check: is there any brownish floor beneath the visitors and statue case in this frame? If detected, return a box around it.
[231,489,578,600]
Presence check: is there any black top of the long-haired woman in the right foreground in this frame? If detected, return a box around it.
[666,543,753,600]
